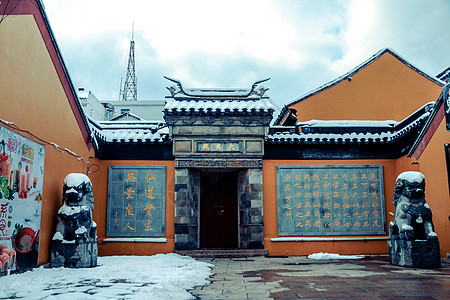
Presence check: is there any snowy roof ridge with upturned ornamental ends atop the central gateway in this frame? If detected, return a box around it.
[163,76,270,98]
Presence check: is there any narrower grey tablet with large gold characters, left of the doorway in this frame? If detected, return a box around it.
[106,166,166,237]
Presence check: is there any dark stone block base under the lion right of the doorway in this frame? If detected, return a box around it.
[388,238,441,268]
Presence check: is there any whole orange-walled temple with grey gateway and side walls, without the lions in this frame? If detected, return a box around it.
[0,1,450,272]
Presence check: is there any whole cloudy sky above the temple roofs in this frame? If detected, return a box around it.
[44,0,450,106]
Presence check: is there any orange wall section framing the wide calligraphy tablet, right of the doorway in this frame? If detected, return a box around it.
[263,160,396,256]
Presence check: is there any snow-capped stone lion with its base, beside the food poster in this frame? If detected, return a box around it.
[51,173,98,268]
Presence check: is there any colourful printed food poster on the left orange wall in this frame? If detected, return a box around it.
[0,126,45,274]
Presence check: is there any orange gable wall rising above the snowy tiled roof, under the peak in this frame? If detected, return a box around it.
[289,53,442,121]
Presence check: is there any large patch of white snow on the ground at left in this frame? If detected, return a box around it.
[0,253,213,300]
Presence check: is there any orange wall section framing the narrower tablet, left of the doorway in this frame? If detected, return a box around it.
[89,159,175,255]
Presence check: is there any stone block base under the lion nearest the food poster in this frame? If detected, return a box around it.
[50,240,98,268]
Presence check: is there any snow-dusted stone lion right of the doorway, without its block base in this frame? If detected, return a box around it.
[389,171,437,240]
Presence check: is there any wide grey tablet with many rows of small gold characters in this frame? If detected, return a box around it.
[277,165,386,236]
